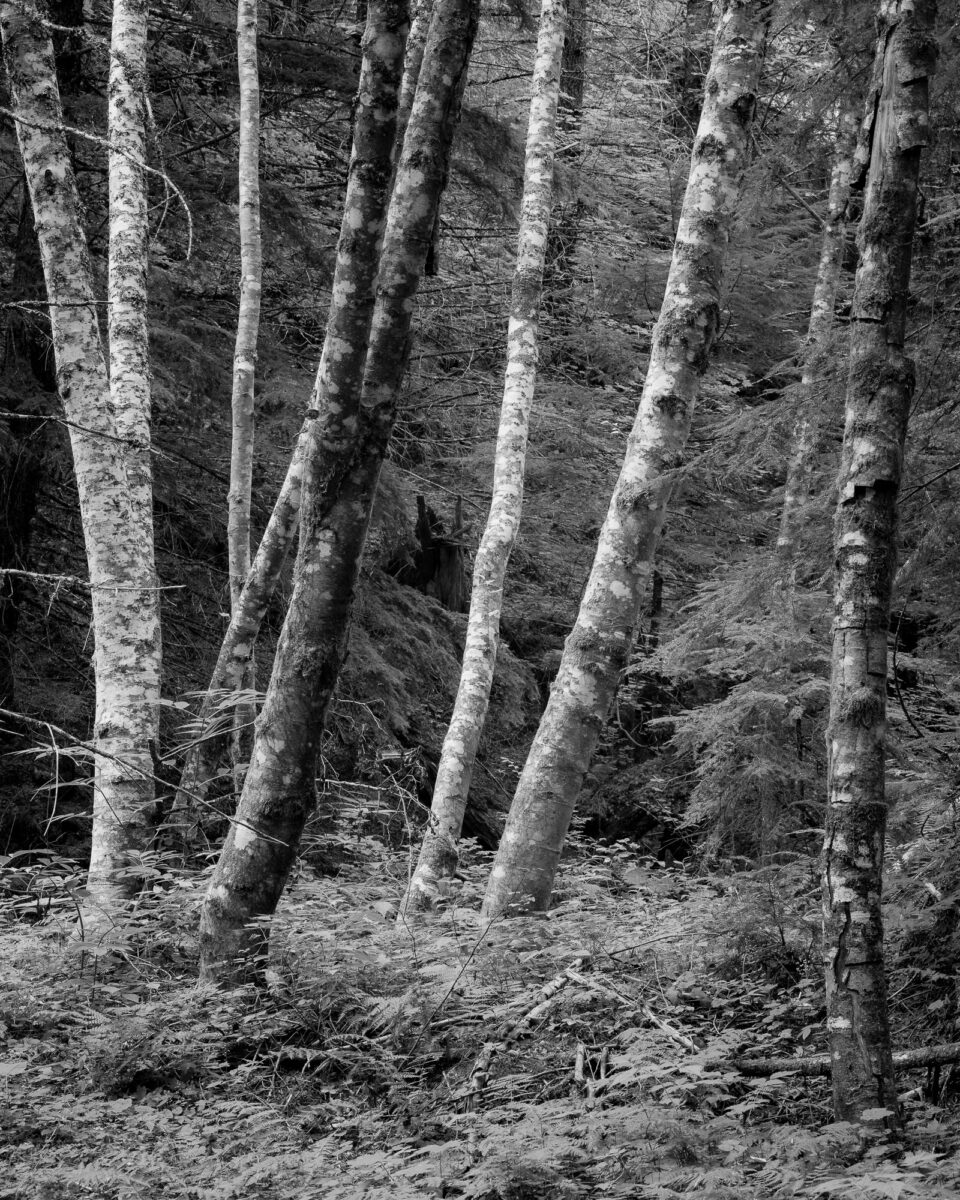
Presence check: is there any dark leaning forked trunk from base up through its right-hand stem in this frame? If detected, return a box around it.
[200,0,479,983]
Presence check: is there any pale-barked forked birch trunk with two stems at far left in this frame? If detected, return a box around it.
[0,0,160,911]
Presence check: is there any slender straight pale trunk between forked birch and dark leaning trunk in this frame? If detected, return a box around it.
[227,0,263,757]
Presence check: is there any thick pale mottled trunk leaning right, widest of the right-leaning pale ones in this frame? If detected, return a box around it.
[484,0,770,918]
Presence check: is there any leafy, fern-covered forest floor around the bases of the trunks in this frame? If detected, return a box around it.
[0,838,960,1200]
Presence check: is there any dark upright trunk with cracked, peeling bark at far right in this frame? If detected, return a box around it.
[823,0,936,1127]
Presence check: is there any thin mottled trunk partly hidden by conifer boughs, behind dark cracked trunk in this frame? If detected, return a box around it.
[776,92,863,576]
